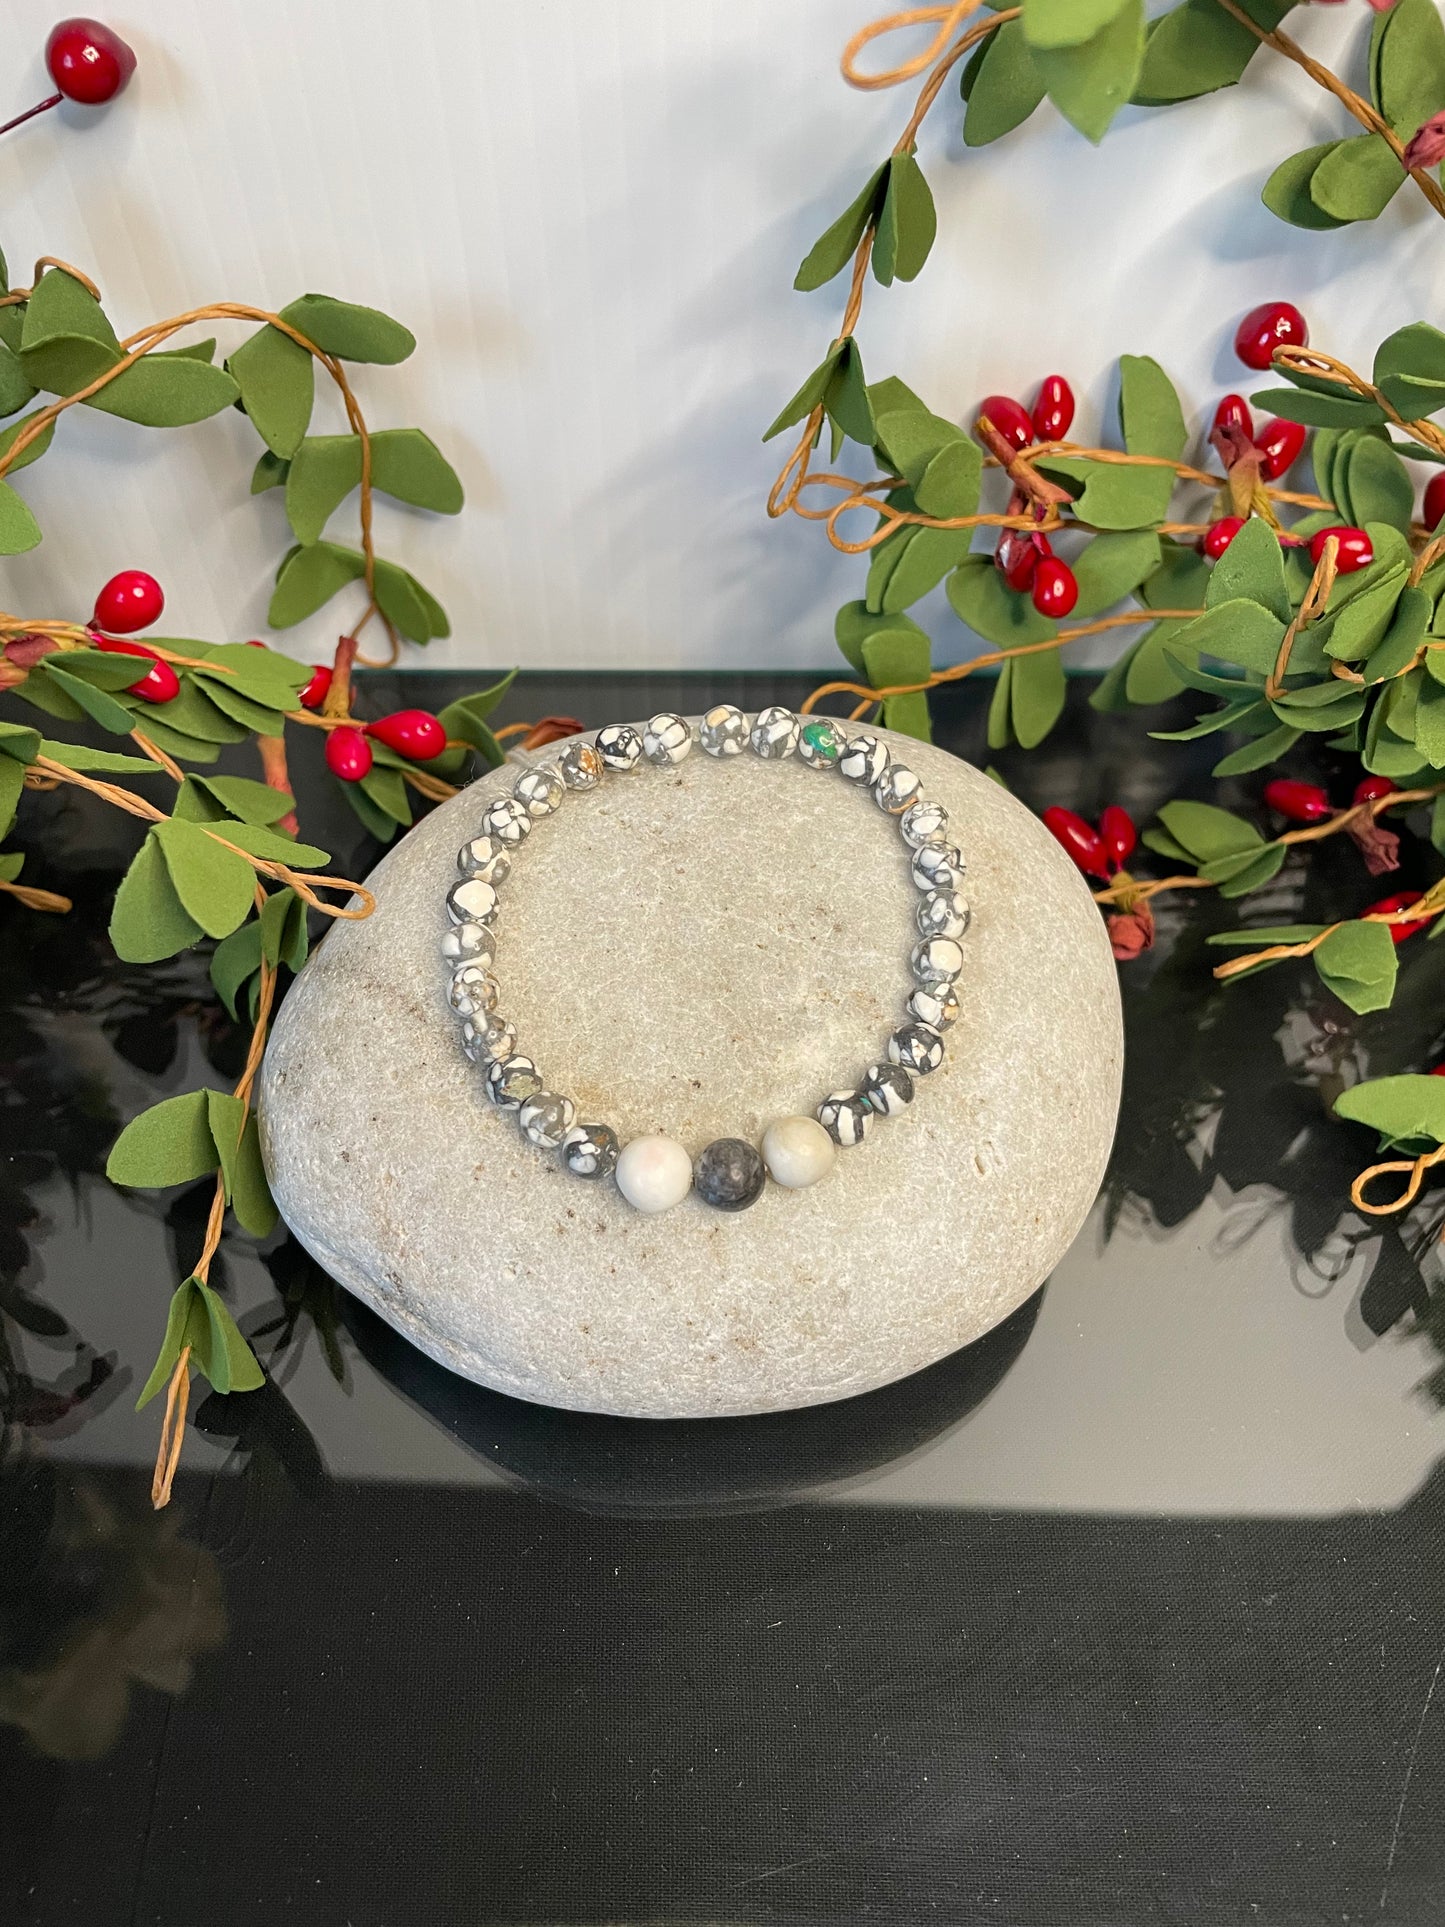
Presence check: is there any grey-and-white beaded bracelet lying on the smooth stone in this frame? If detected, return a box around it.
[441,703,971,1212]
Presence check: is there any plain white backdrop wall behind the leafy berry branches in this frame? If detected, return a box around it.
[0,0,1441,669]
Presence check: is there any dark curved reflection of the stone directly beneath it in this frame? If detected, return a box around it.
[345,1291,1042,1517]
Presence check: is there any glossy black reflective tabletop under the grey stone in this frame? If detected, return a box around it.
[0,674,1445,1927]
